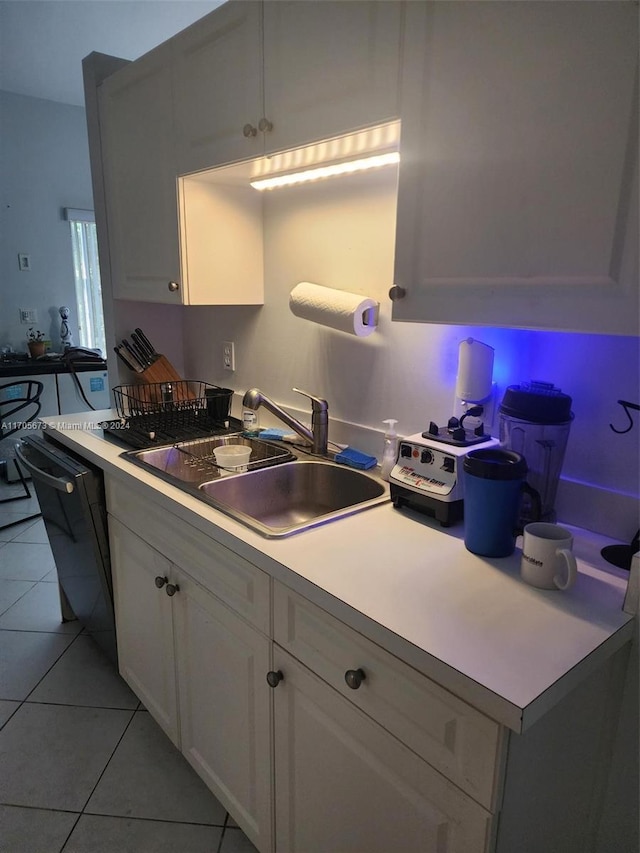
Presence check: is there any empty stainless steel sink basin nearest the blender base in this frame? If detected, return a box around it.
[199,460,389,538]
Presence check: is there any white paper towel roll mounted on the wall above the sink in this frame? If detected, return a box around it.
[289,281,380,338]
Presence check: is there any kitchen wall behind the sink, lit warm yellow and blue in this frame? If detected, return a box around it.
[184,165,640,541]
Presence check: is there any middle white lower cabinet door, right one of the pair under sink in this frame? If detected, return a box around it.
[174,573,272,851]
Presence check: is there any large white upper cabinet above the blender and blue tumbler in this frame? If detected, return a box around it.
[393,0,639,334]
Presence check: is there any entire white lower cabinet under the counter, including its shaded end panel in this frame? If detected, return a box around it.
[106,477,628,853]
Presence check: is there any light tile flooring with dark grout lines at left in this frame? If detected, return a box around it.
[0,483,255,853]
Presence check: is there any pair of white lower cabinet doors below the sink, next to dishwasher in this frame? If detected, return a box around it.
[109,515,273,851]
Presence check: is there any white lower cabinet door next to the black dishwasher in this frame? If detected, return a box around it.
[109,515,179,745]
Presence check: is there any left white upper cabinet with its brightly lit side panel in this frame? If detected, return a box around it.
[100,25,264,305]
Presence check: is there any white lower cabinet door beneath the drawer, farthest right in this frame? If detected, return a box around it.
[274,646,491,853]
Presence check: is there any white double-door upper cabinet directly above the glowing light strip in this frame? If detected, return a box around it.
[172,0,404,175]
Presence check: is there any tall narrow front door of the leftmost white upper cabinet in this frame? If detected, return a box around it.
[99,43,182,304]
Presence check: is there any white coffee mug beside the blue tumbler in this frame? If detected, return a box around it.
[520,521,578,589]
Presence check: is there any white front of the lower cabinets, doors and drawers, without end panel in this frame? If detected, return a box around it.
[107,492,498,853]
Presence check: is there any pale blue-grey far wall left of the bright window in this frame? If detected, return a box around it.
[0,91,93,352]
